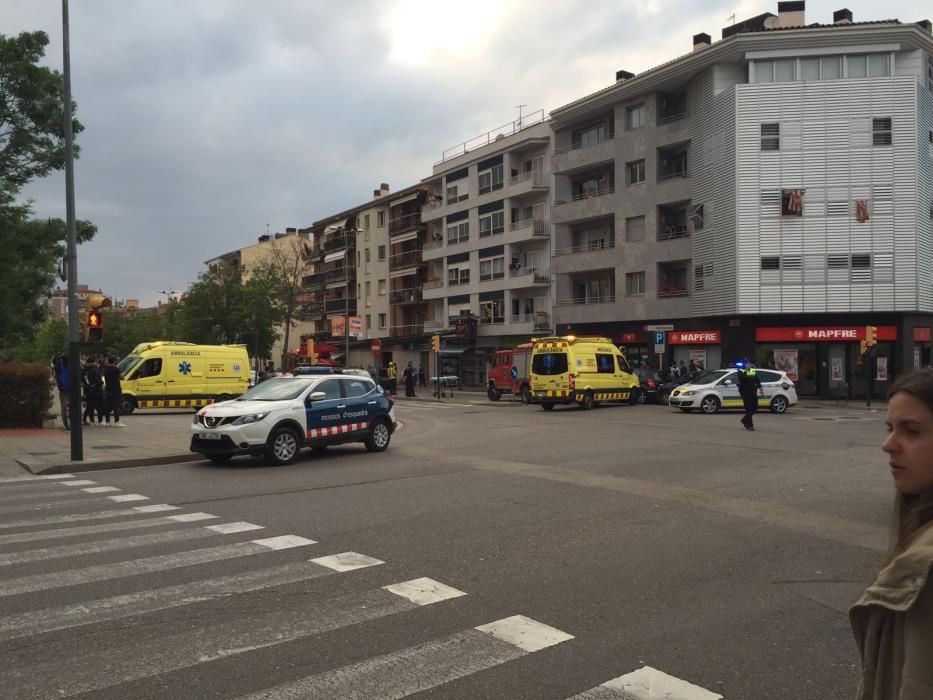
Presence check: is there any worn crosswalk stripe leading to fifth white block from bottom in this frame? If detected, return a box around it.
[0,538,311,597]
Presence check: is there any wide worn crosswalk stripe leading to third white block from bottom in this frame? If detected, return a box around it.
[3,582,462,697]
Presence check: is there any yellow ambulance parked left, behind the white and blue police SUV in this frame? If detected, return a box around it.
[117,340,249,415]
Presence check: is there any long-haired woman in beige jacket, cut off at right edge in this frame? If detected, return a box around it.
[849,368,933,700]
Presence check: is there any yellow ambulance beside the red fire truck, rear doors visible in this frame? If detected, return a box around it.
[530,335,641,411]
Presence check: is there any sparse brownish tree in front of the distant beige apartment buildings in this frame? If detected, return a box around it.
[248,236,307,367]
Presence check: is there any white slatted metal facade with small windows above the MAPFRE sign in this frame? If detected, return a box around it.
[736,76,933,313]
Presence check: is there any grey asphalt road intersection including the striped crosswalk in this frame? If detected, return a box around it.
[0,397,891,700]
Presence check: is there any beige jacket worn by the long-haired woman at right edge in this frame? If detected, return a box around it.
[849,527,933,700]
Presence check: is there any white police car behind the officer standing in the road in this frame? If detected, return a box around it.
[668,369,797,413]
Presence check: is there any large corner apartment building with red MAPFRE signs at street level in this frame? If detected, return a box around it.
[550,2,933,396]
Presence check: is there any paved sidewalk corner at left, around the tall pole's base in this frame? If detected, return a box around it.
[0,412,201,479]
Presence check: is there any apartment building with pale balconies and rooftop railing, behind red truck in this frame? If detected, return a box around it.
[422,110,553,384]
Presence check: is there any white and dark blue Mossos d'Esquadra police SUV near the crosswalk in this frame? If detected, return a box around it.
[191,374,396,464]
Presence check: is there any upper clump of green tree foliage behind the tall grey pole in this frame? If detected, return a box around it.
[0,32,84,207]
